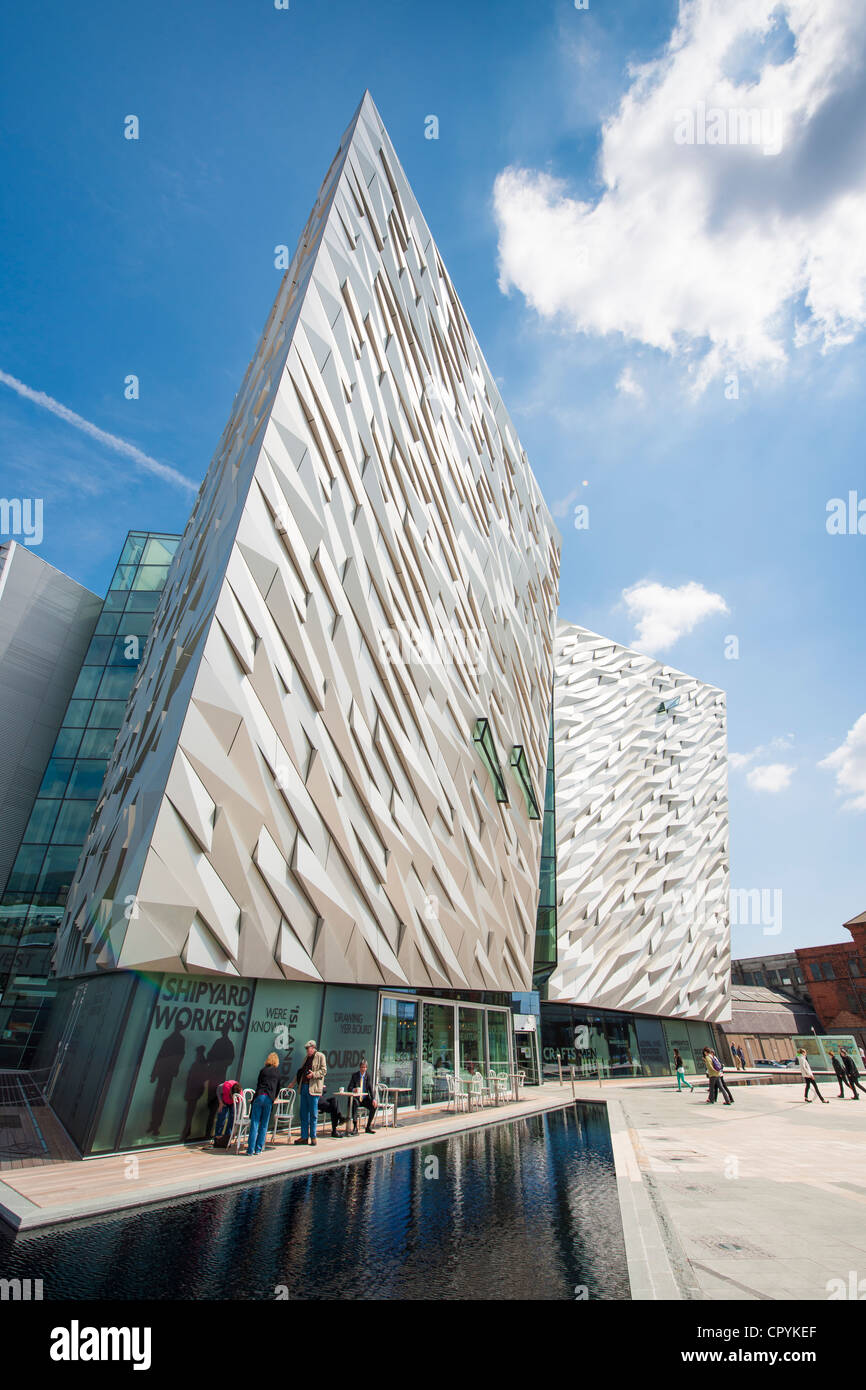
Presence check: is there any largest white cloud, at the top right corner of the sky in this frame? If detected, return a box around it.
[493,0,866,386]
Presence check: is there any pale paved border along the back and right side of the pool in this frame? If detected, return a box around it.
[0,1083,683,1300]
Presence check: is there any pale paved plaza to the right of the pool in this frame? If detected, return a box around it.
[600,1081,866,1300]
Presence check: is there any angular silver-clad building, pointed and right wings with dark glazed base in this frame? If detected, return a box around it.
[3,96,727,1152]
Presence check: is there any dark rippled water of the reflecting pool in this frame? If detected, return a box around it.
[0,1104,630,1300]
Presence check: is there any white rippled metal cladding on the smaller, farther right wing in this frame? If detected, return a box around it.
[548,623,730,1022]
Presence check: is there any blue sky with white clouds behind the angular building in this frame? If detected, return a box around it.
[0,0,866,955]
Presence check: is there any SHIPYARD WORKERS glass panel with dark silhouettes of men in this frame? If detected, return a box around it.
[121,974,253,1148]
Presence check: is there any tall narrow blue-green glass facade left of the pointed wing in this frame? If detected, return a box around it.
[0,531,181,1068]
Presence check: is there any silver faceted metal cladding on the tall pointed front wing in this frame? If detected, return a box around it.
[57,96,559,990]
